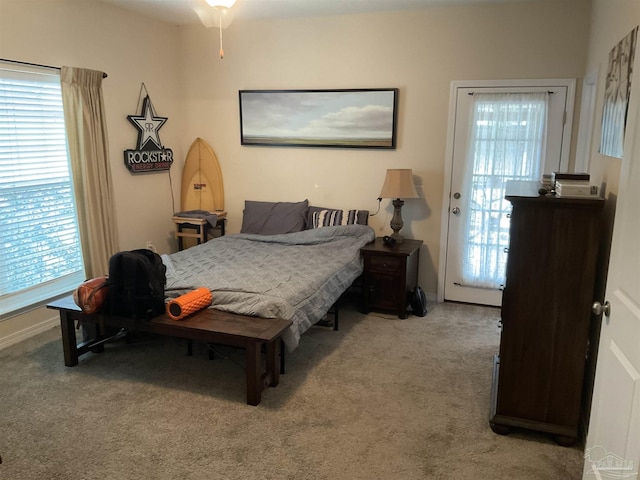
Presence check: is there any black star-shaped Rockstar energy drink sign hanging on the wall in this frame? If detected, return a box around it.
[124,95,173,173]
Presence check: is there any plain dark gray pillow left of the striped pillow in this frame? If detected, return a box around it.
[240,200,309,235]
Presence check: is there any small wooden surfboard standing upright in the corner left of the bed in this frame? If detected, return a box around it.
[180,137,224,212]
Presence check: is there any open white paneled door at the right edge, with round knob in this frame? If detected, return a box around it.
[583,91,640,480]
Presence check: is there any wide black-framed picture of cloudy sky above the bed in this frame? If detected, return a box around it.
[239,88,398,149]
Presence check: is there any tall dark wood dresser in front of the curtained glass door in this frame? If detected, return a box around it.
[490,182,604,445]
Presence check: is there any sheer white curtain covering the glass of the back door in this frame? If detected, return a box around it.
[460,92,549,289]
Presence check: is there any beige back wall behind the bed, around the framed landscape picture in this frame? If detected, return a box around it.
[180,1,590,297]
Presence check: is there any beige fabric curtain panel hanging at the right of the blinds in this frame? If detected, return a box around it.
[60,67,118,278]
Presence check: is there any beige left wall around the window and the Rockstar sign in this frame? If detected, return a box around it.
[0,0,184,348]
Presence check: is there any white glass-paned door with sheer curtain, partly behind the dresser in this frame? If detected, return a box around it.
[441,81,573,306]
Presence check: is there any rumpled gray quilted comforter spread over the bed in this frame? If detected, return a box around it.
[162,225,375,351]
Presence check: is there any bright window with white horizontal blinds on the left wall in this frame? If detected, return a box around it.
[0,62,84,318]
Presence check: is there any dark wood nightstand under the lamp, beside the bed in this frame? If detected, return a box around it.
[360,237,422,318]
